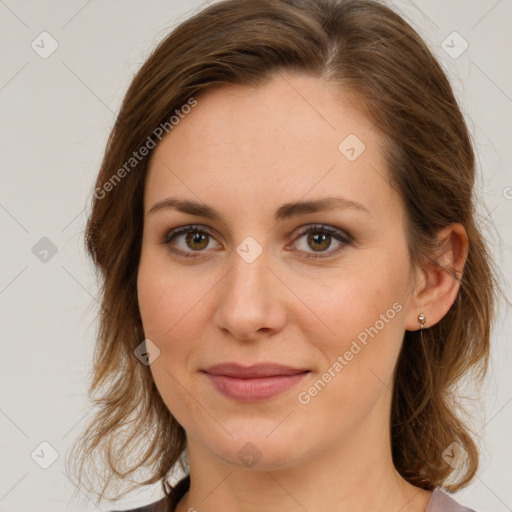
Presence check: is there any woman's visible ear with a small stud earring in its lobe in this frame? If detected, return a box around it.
[405,223,468,331]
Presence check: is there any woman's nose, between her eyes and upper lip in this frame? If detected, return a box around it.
[214,245,286,340]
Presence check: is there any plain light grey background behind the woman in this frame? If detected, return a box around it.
[0,0,512,512]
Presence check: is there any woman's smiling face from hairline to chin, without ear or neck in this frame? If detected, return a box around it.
[138,74,418,469]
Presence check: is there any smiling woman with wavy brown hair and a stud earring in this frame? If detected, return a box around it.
[68,0,495,512]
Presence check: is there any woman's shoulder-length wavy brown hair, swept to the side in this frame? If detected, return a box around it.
[67,0,496,504]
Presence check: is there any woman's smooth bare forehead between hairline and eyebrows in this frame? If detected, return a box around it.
[145,74,391,222]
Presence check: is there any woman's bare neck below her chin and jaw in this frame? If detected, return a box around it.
[176,416,432,512]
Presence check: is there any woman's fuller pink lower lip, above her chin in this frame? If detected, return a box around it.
[206,372,309,402]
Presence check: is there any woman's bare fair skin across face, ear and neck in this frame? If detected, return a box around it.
[138,74,467,512]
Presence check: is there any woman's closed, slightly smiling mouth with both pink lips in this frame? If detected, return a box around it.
[202,363,310,402]
